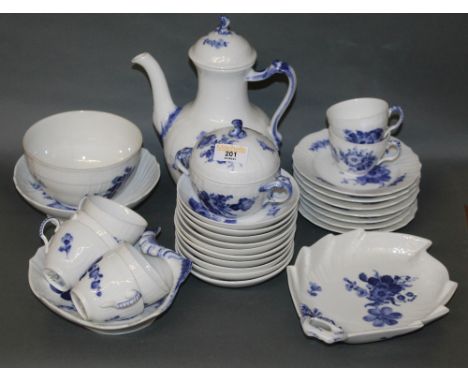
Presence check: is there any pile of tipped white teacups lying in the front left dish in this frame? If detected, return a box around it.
[40,196,173,322]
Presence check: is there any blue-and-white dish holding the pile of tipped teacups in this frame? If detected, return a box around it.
[28,236,191,334]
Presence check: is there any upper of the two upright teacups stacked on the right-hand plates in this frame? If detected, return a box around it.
[327,98,404,144]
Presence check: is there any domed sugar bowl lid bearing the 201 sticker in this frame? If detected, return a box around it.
[189,119,280,185]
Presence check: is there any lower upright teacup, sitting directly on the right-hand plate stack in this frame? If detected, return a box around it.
[329,131,400,175]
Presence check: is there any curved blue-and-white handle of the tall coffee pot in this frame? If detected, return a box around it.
[246,60,297,148]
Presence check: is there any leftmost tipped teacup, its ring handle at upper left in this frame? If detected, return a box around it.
[39,211,119,292]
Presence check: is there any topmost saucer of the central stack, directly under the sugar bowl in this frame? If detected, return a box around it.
[177,170,299,230]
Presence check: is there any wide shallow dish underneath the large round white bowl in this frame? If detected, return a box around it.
[13,148,161,219]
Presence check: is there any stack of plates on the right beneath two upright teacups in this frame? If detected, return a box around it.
[293,129,421,233]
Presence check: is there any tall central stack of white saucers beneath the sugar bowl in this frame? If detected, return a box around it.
[174,170,299,288]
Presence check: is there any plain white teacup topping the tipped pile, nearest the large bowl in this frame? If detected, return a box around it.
[79,196,148,244]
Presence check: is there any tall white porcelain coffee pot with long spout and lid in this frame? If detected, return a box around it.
[132,16,296,181]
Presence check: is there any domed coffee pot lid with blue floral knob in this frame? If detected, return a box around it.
[189,16,257,70]
